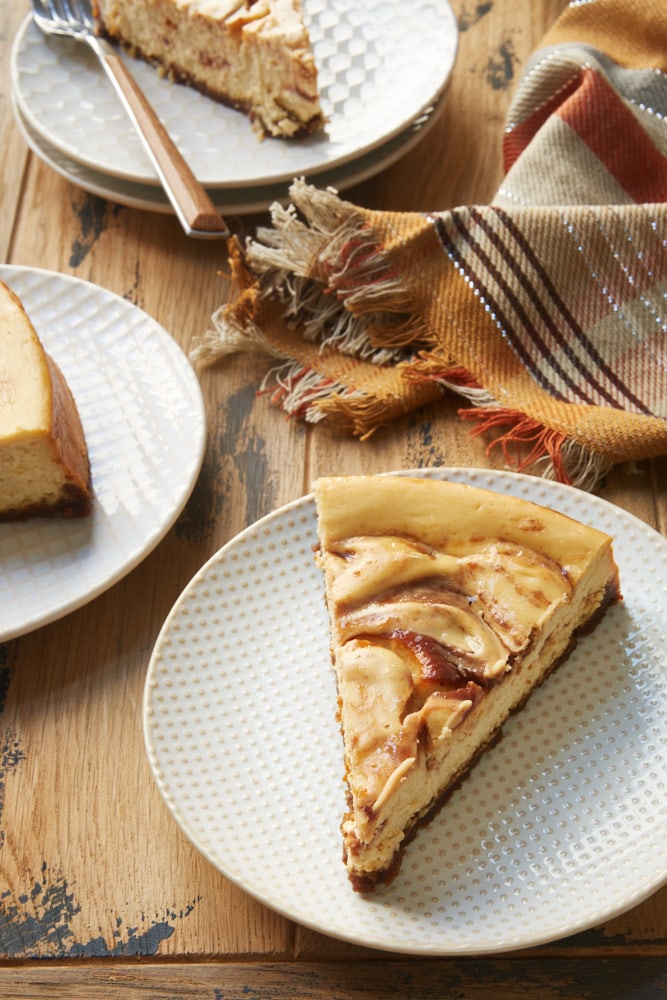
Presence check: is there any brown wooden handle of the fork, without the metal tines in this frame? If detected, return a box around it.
[94,38,229,239]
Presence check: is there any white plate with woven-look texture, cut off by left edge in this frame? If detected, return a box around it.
[0,267,206,641]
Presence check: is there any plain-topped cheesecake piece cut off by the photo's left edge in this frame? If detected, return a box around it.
[0,282,92,521]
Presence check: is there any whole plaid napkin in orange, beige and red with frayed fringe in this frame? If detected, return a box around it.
[194,0,667,489]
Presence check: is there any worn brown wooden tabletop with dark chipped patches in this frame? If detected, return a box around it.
[0,0,667,1000]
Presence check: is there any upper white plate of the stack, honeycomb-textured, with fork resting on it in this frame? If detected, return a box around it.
[11,0,458,188]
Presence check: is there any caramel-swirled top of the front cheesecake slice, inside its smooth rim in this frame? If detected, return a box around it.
[329,535,572,851]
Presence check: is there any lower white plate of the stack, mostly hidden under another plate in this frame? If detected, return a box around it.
[12,86,444,215]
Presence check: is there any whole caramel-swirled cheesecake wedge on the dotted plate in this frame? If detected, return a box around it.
[315,476,620,891]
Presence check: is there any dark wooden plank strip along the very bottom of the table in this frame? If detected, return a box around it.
[0,955,667,1000]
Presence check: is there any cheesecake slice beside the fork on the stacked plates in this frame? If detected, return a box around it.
[93,0,324,139]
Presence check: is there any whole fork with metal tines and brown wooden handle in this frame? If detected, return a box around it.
[32,0,229,239]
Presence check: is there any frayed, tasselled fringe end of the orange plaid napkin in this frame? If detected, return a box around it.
[191,180,613,489]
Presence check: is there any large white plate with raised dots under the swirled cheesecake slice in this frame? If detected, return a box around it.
[144,469,667,955]
